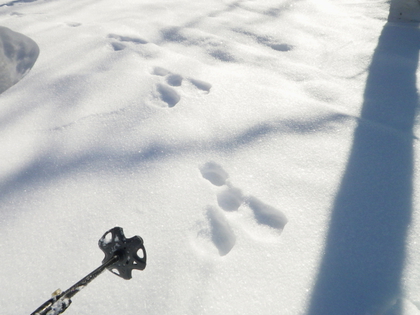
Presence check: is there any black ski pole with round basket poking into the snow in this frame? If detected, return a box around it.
[31,227,146,315]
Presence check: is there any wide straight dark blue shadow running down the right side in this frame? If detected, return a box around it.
[307,23,420,315]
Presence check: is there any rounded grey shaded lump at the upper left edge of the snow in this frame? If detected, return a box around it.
[0,26,39,93]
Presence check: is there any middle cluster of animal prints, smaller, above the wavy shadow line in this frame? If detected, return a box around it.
[152,67,211,107]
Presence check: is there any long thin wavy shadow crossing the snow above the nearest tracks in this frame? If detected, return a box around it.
[0,113,349,225]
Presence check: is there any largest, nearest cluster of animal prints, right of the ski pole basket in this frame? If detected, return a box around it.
[200,161,287,256]
